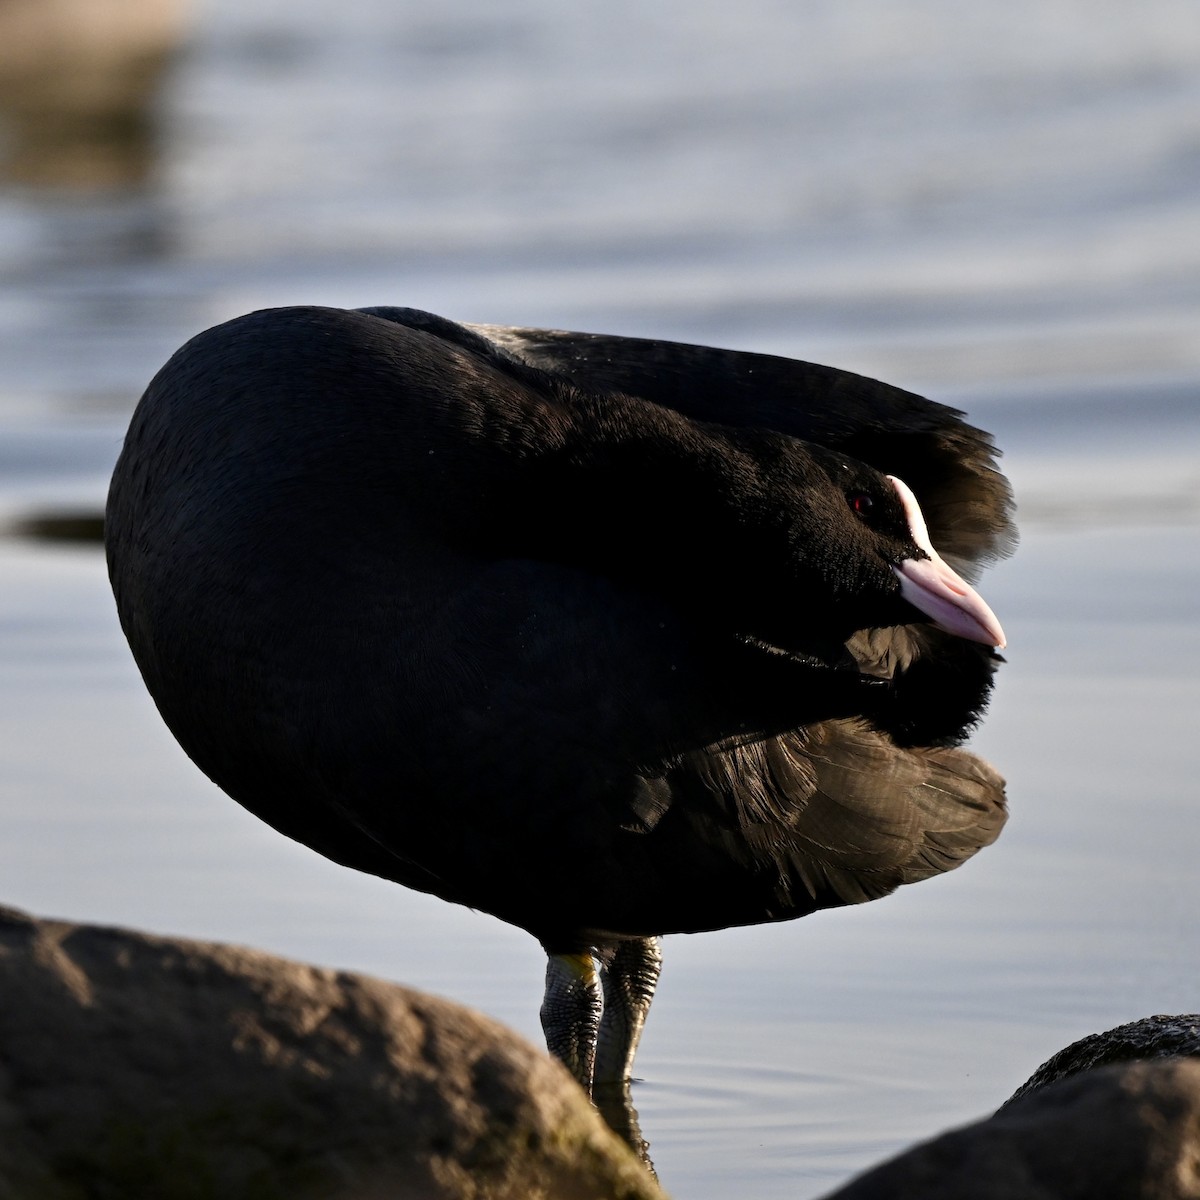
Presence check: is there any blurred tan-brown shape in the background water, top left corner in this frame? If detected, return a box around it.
[0,0,182,188]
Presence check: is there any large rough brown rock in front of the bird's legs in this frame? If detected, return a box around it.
[0,910,662,1200]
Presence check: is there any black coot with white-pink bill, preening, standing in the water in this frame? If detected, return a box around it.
[107,308,1013,1086]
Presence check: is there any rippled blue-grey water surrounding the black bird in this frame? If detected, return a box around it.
[0,0,1200,1200]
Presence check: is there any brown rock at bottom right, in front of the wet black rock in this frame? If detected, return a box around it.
[827,1058,1200,1200]
